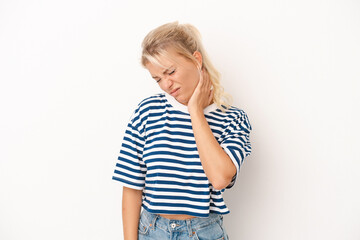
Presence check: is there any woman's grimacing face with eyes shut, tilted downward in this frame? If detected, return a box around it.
[146,49,201,105]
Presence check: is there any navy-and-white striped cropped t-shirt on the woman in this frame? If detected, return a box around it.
[112,93,251,217]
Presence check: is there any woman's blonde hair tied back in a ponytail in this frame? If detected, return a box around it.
[141,21,232,112]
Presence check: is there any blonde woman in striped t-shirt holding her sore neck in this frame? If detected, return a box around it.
[113,22,251,240]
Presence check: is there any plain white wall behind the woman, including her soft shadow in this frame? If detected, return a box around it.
[0,0,360,240]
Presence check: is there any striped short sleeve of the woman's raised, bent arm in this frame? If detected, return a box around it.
[220,111,252,188]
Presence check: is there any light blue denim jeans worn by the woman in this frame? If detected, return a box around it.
[138,209,229,240]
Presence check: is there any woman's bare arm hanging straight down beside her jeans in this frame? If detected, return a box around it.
[122,187,142,240]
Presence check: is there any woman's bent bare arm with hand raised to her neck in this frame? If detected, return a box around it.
[188,70,236,190]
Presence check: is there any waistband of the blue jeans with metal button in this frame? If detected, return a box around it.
[140,209,223,232]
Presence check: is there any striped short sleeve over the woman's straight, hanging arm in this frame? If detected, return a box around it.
[112,108,147,190]
